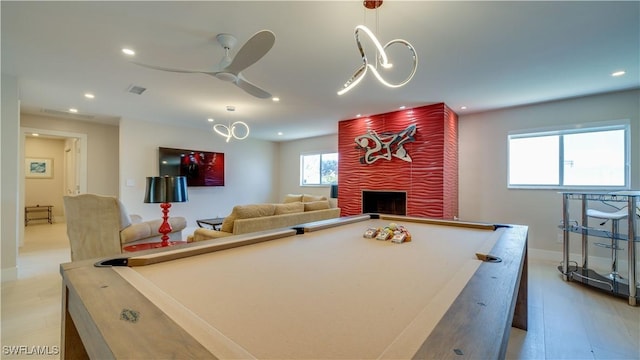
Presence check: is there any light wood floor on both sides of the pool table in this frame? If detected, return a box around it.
[0,224,640,359]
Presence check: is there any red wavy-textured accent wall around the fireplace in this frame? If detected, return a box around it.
[338,103,458,219]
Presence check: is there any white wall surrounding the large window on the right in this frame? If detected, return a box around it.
[459,90,640,253]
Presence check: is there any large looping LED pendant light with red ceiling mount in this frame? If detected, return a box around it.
[338,0,418,95]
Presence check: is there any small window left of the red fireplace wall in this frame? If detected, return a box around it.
[300,153,338,185]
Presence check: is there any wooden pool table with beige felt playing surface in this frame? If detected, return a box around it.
[61,214,528,359]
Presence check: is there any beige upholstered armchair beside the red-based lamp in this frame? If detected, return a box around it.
[63,194,187,261]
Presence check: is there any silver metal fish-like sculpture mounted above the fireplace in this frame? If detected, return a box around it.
[355,124,416,164]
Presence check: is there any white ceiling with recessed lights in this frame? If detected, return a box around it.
[1,0,640,141]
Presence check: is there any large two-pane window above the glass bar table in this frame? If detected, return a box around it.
[508,122,630,189]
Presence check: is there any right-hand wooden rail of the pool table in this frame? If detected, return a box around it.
[415,225,528,359]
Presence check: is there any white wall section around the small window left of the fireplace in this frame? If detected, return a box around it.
[277,135,339,199]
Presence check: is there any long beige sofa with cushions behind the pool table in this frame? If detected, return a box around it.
[188,194,340,242]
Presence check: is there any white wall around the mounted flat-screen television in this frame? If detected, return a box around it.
[120,119,280,229]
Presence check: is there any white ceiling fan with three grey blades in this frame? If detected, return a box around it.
[132,30,276,99]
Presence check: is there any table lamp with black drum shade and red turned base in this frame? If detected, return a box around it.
[144,176,187,247]
